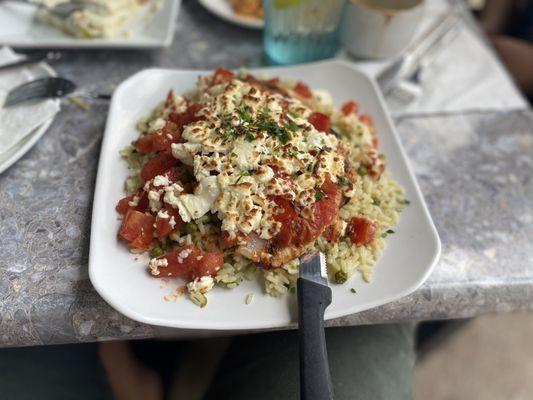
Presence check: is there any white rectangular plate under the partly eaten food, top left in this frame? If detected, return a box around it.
[0,0,181,49]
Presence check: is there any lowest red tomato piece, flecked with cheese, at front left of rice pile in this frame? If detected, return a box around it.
[151,245,224,279]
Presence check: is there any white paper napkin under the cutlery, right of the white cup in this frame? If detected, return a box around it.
[348,0,528,116]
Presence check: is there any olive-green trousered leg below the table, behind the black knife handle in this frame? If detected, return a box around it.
[205,325,415,400]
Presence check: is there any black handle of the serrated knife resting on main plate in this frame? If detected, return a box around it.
[297,278,333,400]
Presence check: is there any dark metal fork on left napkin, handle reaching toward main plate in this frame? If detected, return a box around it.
[4,77,111,108]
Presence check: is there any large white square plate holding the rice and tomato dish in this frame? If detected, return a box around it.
[89,61,440,330]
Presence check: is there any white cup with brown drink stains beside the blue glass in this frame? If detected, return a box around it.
[341,0,425,59]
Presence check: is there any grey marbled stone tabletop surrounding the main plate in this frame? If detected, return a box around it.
[0,2,533,346]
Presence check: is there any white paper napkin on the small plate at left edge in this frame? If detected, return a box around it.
[0,47,59,155]
